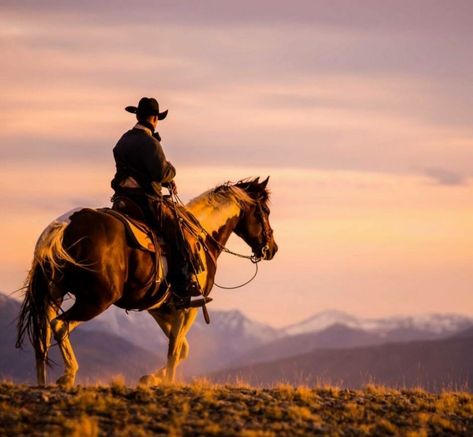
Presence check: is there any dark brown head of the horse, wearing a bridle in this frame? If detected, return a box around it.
[235,177,278,260]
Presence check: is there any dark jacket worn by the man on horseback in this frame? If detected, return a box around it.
[112,123,176,194]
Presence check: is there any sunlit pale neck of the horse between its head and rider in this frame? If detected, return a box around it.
[188,200,241,256]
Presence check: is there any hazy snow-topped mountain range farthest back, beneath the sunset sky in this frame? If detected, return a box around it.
[84,307,473,376]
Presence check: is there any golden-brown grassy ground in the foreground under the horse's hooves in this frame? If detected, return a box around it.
[0,382,473,436]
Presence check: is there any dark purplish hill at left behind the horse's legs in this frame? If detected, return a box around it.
[0,293,165,383]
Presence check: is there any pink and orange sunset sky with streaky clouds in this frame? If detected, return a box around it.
[0,0,473,326]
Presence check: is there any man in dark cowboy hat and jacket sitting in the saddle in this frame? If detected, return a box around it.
[112,97,205,308]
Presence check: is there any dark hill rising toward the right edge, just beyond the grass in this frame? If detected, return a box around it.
[207,335,473,391]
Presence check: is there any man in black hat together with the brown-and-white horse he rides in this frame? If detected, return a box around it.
[16,98,278,386]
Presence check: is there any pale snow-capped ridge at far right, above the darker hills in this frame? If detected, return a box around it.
[282,310,473,335]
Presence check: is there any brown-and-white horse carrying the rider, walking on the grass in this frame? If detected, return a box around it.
[16,177,278,386]
